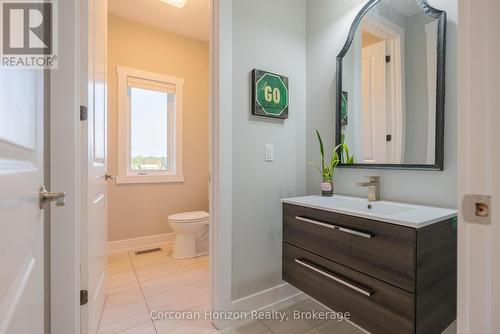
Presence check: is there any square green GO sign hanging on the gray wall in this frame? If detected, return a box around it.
[252,70,289,119]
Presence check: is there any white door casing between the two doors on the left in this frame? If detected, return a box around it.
[49,0,81,334]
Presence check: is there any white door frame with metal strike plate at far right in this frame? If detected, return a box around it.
[457,0,500,334]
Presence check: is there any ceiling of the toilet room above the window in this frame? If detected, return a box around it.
[109,0,210,41]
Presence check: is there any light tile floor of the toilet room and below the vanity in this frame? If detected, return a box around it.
[98,244,456,334]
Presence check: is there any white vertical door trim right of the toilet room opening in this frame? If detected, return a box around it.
[209,0,233,328]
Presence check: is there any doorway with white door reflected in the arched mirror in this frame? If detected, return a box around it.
[360,15,406,163]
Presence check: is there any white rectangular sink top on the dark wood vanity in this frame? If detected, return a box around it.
[281,195,457,228]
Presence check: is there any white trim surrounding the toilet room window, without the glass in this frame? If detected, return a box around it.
[116,66,184,183]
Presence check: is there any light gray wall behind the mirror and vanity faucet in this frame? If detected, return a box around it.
[306,0,458,207]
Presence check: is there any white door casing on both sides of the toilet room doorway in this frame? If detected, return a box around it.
[50,0,232,334]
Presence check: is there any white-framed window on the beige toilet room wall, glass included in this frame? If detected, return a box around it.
[116,67,184,183]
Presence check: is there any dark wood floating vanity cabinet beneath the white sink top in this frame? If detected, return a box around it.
[283,203,457,334]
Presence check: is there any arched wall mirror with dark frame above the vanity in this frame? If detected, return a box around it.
[335,0,446,170]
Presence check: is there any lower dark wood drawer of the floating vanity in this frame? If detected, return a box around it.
[283,242,414,334]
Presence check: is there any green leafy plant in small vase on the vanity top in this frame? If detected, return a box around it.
[308,130,354,197]
